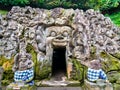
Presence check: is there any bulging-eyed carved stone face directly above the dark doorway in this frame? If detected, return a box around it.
[46,26,72,47]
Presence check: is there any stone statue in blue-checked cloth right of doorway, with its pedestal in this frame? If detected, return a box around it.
[85,60,113,90]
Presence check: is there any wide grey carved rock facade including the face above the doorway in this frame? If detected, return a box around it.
[0,6,120,80]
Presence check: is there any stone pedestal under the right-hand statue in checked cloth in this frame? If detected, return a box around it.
[85,80,113,90]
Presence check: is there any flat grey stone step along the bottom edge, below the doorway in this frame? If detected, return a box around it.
[37,87,82,90]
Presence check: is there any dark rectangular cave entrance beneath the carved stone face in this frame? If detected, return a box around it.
[52,47,67,81]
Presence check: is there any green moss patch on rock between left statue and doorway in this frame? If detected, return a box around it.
[26,44,51,80]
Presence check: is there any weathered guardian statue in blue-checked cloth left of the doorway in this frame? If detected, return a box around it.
[13,41,34,86]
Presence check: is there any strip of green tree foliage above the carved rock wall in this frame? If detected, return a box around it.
[0,0,120,11]
